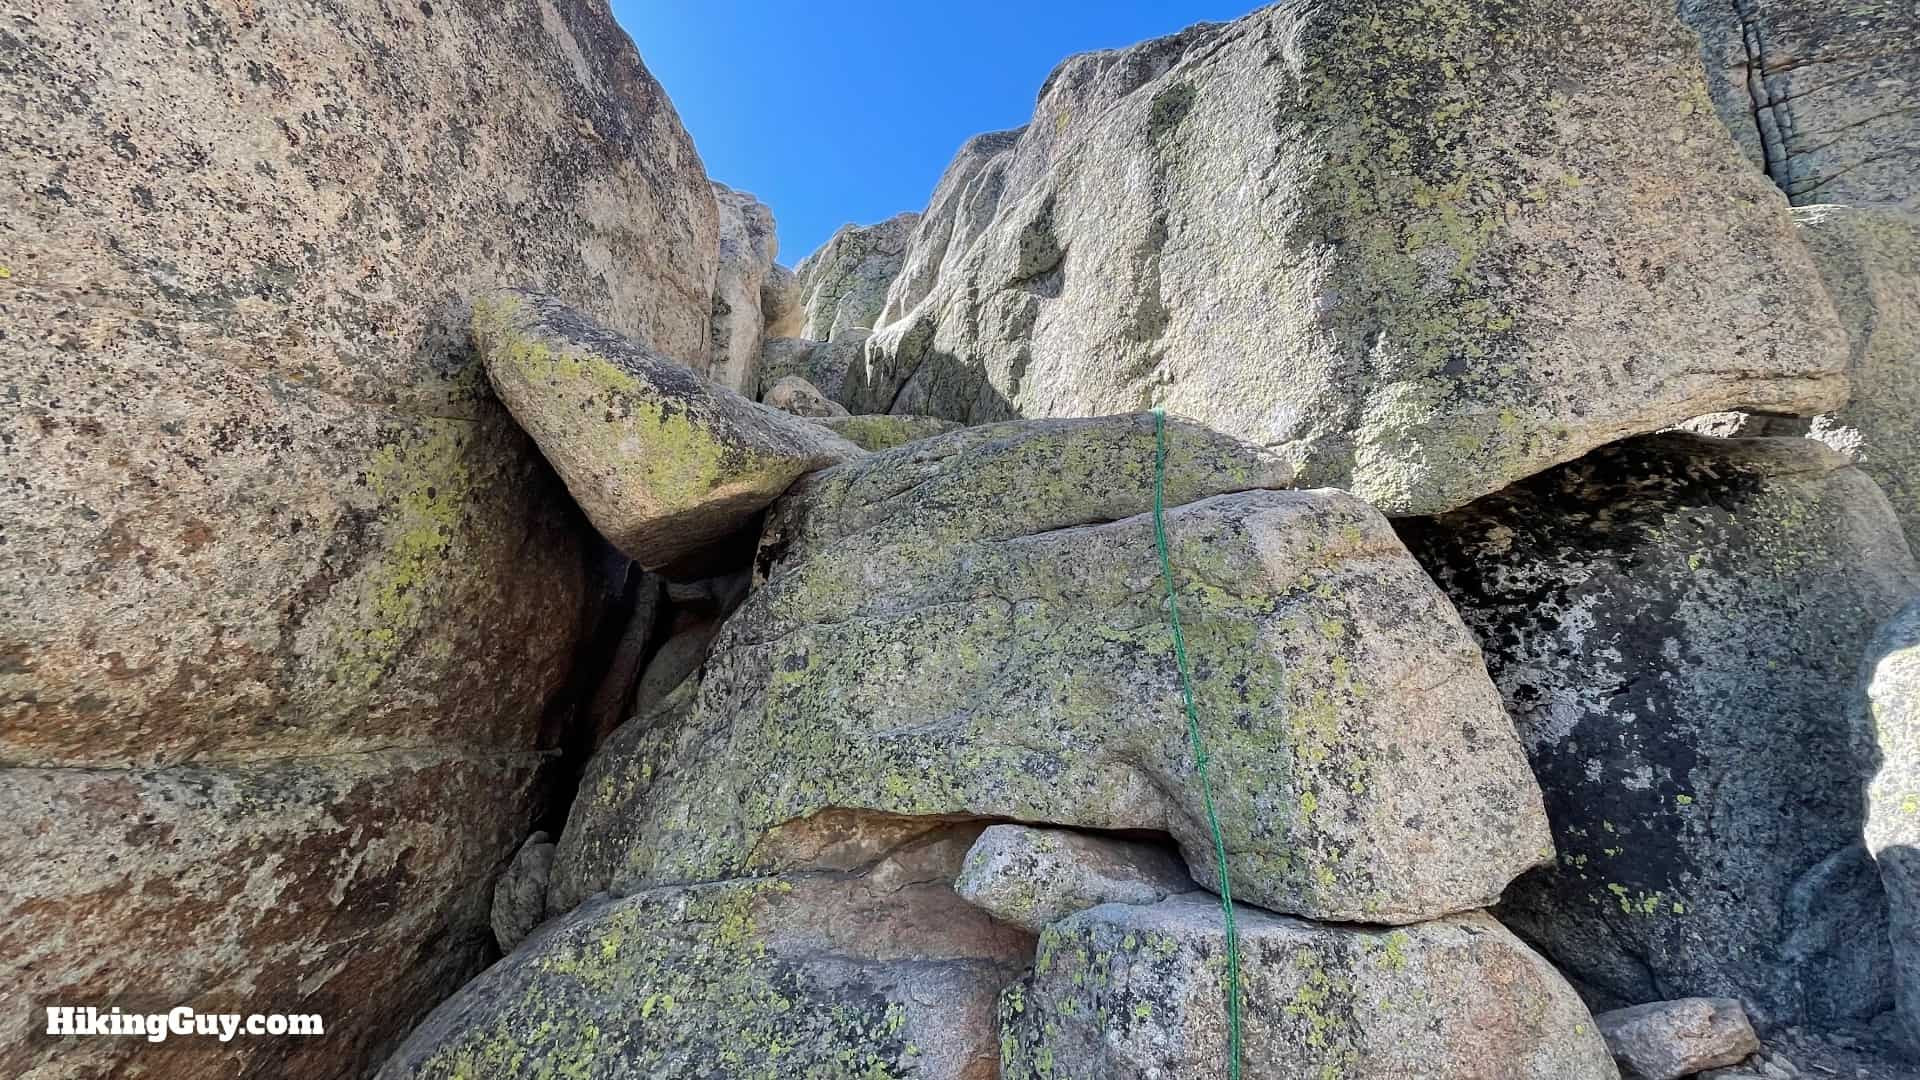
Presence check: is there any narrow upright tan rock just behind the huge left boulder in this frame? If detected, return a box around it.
[697,183,780,396]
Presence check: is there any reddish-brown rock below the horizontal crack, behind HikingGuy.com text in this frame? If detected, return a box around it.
[0,749,540,1080]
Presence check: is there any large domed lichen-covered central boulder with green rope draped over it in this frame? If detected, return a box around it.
[555,415,1549,922]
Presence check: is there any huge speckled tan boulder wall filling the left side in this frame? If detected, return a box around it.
[0,0,716,1076]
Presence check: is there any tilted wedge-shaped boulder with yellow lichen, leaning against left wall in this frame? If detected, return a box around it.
[472,290,864,569]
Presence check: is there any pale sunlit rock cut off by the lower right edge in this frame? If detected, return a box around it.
[1855,600,1920,1045]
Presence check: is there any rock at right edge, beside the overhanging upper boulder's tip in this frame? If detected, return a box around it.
[1793,205,1920,550]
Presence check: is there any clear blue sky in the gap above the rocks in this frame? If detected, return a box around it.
[612,0,1260,265]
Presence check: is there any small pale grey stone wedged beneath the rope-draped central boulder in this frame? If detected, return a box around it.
[954,824,1194,934]
